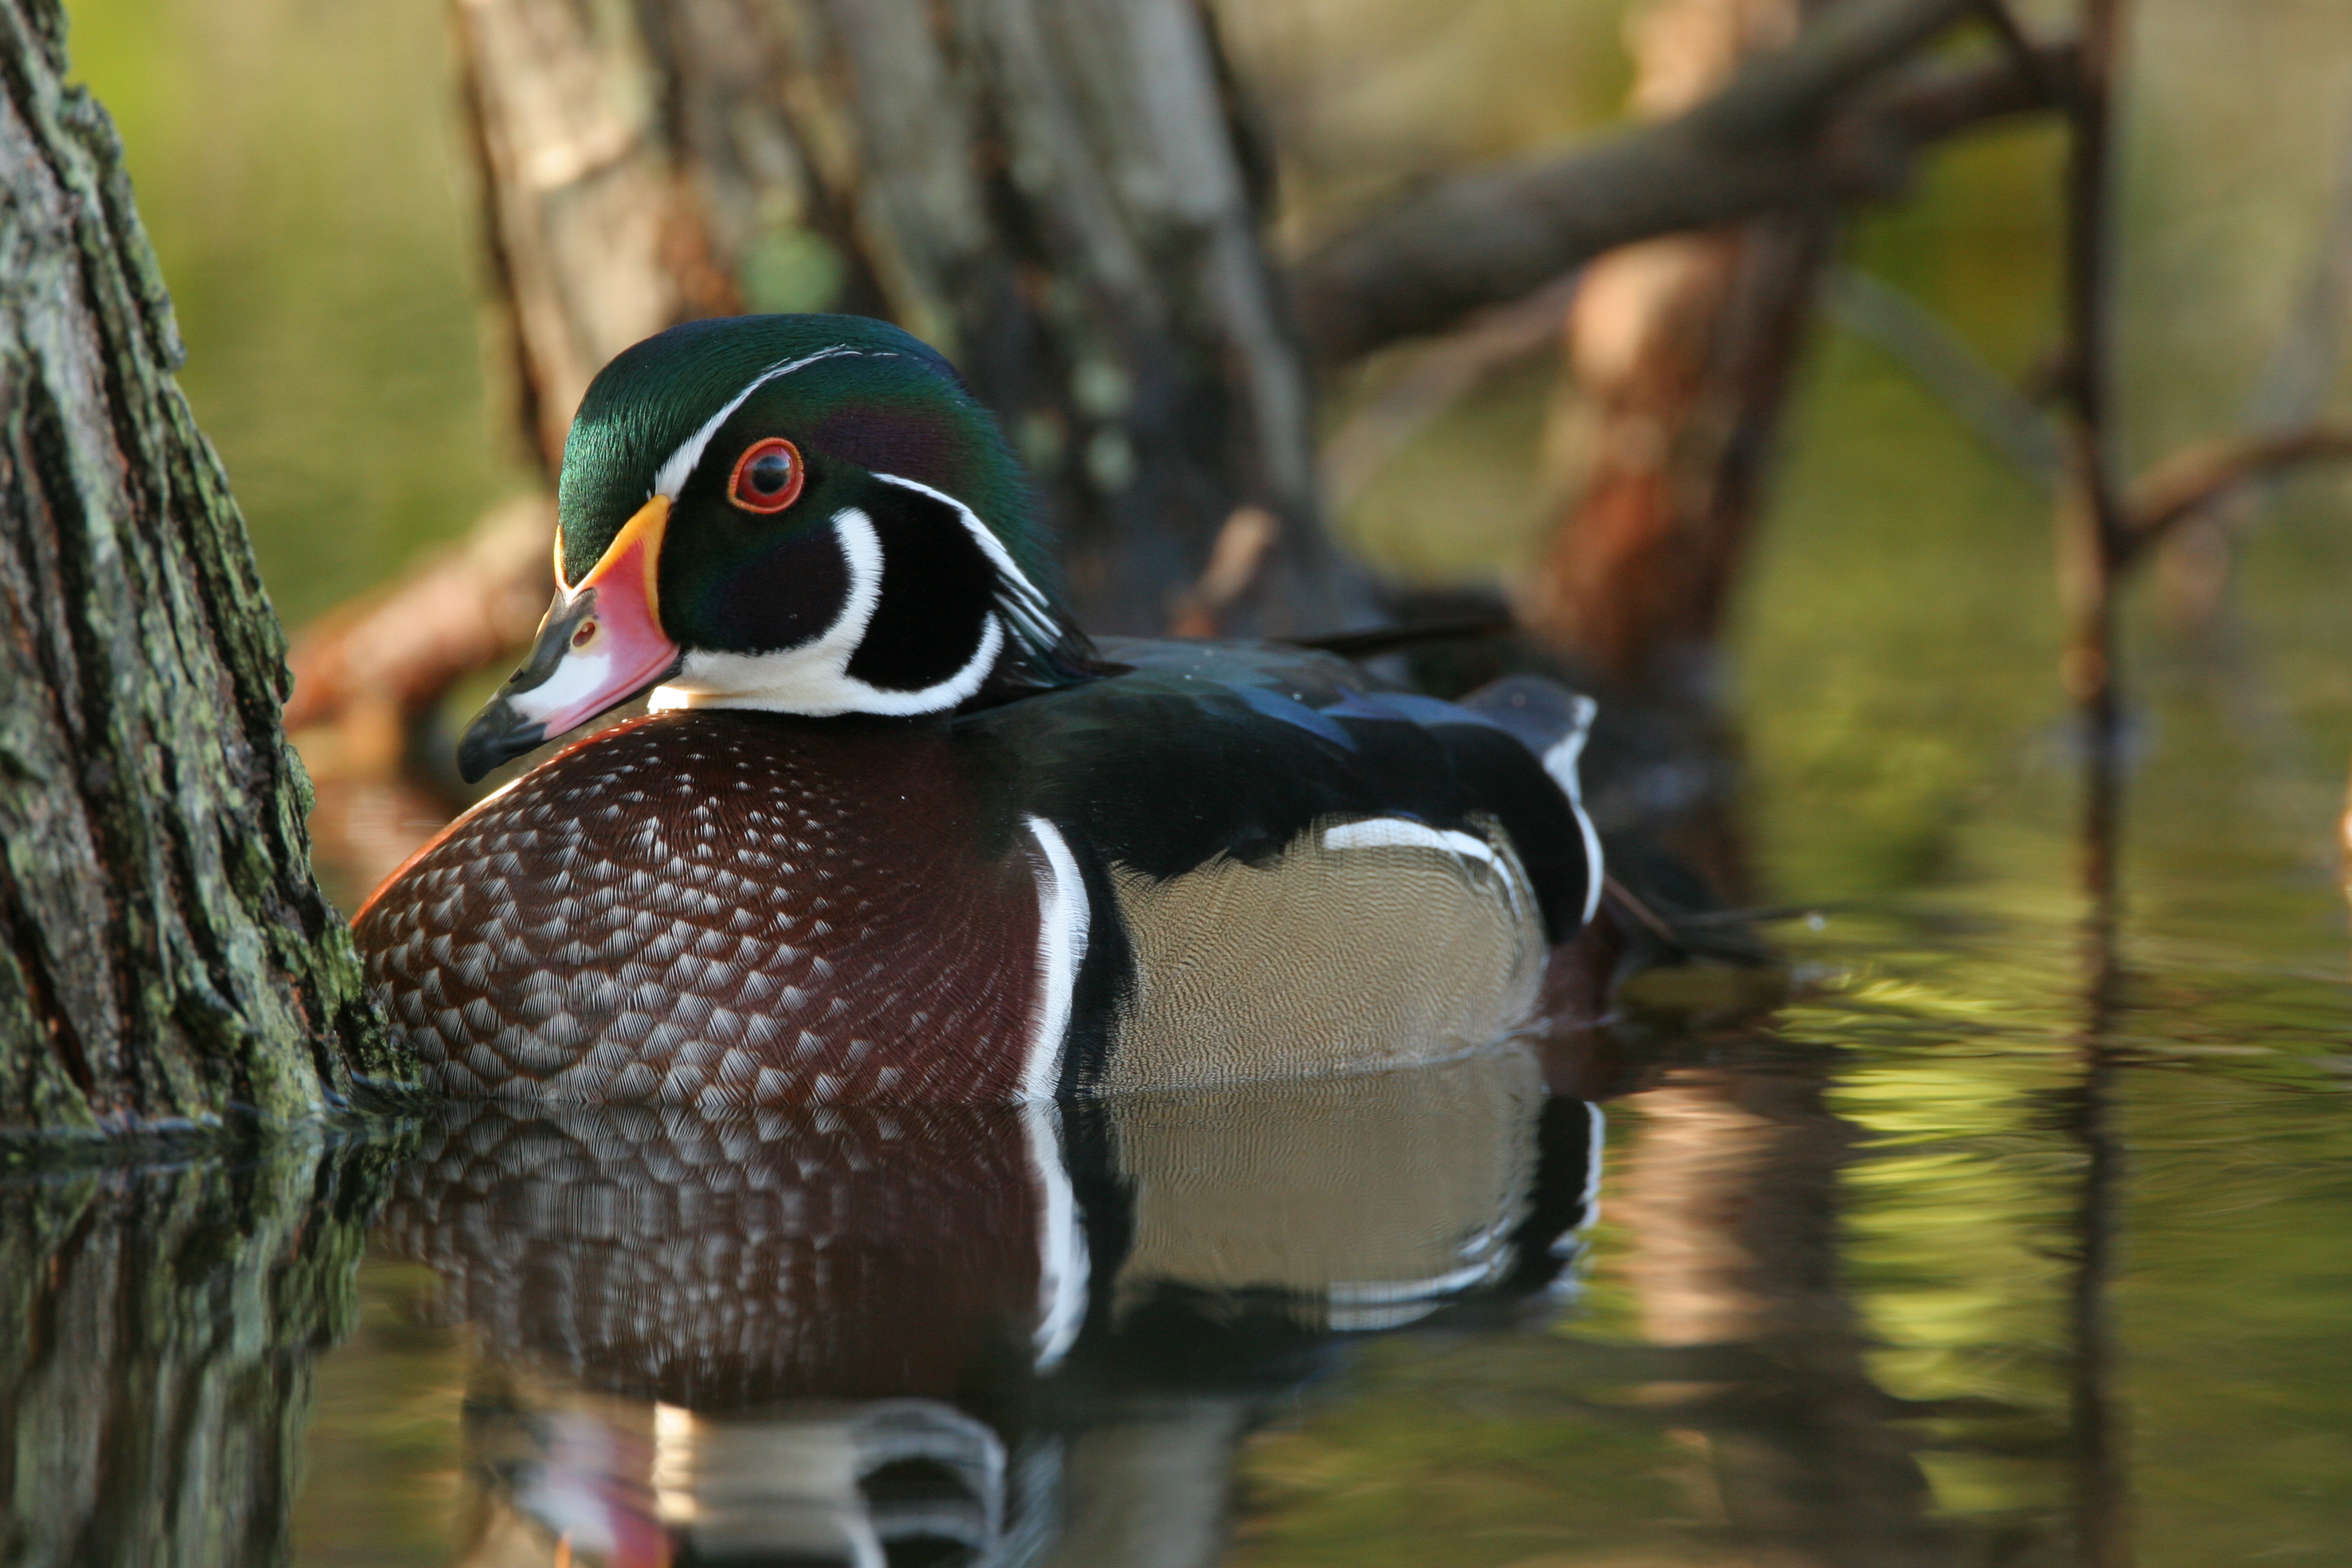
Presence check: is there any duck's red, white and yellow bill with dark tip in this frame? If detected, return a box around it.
[456,496,680,783]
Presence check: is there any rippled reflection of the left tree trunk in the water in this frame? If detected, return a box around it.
[0,1136,393,1568]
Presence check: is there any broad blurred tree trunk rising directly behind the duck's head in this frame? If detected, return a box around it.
[458,0,1364,632]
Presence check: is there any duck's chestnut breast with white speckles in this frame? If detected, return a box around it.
[355,712,1042,1110]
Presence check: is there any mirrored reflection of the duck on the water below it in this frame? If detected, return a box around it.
[386,1048,1600,1568]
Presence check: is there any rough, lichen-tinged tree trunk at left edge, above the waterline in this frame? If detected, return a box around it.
[0,0,405,1131]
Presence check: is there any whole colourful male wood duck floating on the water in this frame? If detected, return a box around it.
[355,315,1600,1112]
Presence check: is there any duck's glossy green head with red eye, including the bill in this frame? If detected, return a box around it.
[458,315,1087,781]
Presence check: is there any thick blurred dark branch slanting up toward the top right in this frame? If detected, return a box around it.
[1293,0,2075,364]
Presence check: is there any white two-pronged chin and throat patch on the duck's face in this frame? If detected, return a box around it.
[647,507,1004,720]
